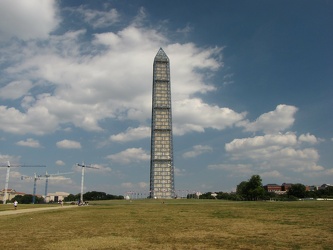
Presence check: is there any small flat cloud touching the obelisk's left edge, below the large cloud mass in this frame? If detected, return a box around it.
[107,148,150,164]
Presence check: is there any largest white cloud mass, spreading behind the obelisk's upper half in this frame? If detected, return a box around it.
[0,6,228,135]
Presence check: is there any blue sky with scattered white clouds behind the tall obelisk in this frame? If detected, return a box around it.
[0,0,333,194]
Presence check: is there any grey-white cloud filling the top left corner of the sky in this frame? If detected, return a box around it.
[0,0,60,40]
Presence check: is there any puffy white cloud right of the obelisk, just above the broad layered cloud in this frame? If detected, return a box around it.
[239,104,297,134]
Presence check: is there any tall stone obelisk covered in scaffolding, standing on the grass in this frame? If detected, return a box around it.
[150,48,175,199]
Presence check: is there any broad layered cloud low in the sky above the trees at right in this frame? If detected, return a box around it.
[225,133,323,176]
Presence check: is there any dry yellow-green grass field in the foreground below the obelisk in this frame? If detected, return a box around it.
[0,200,333,250]
